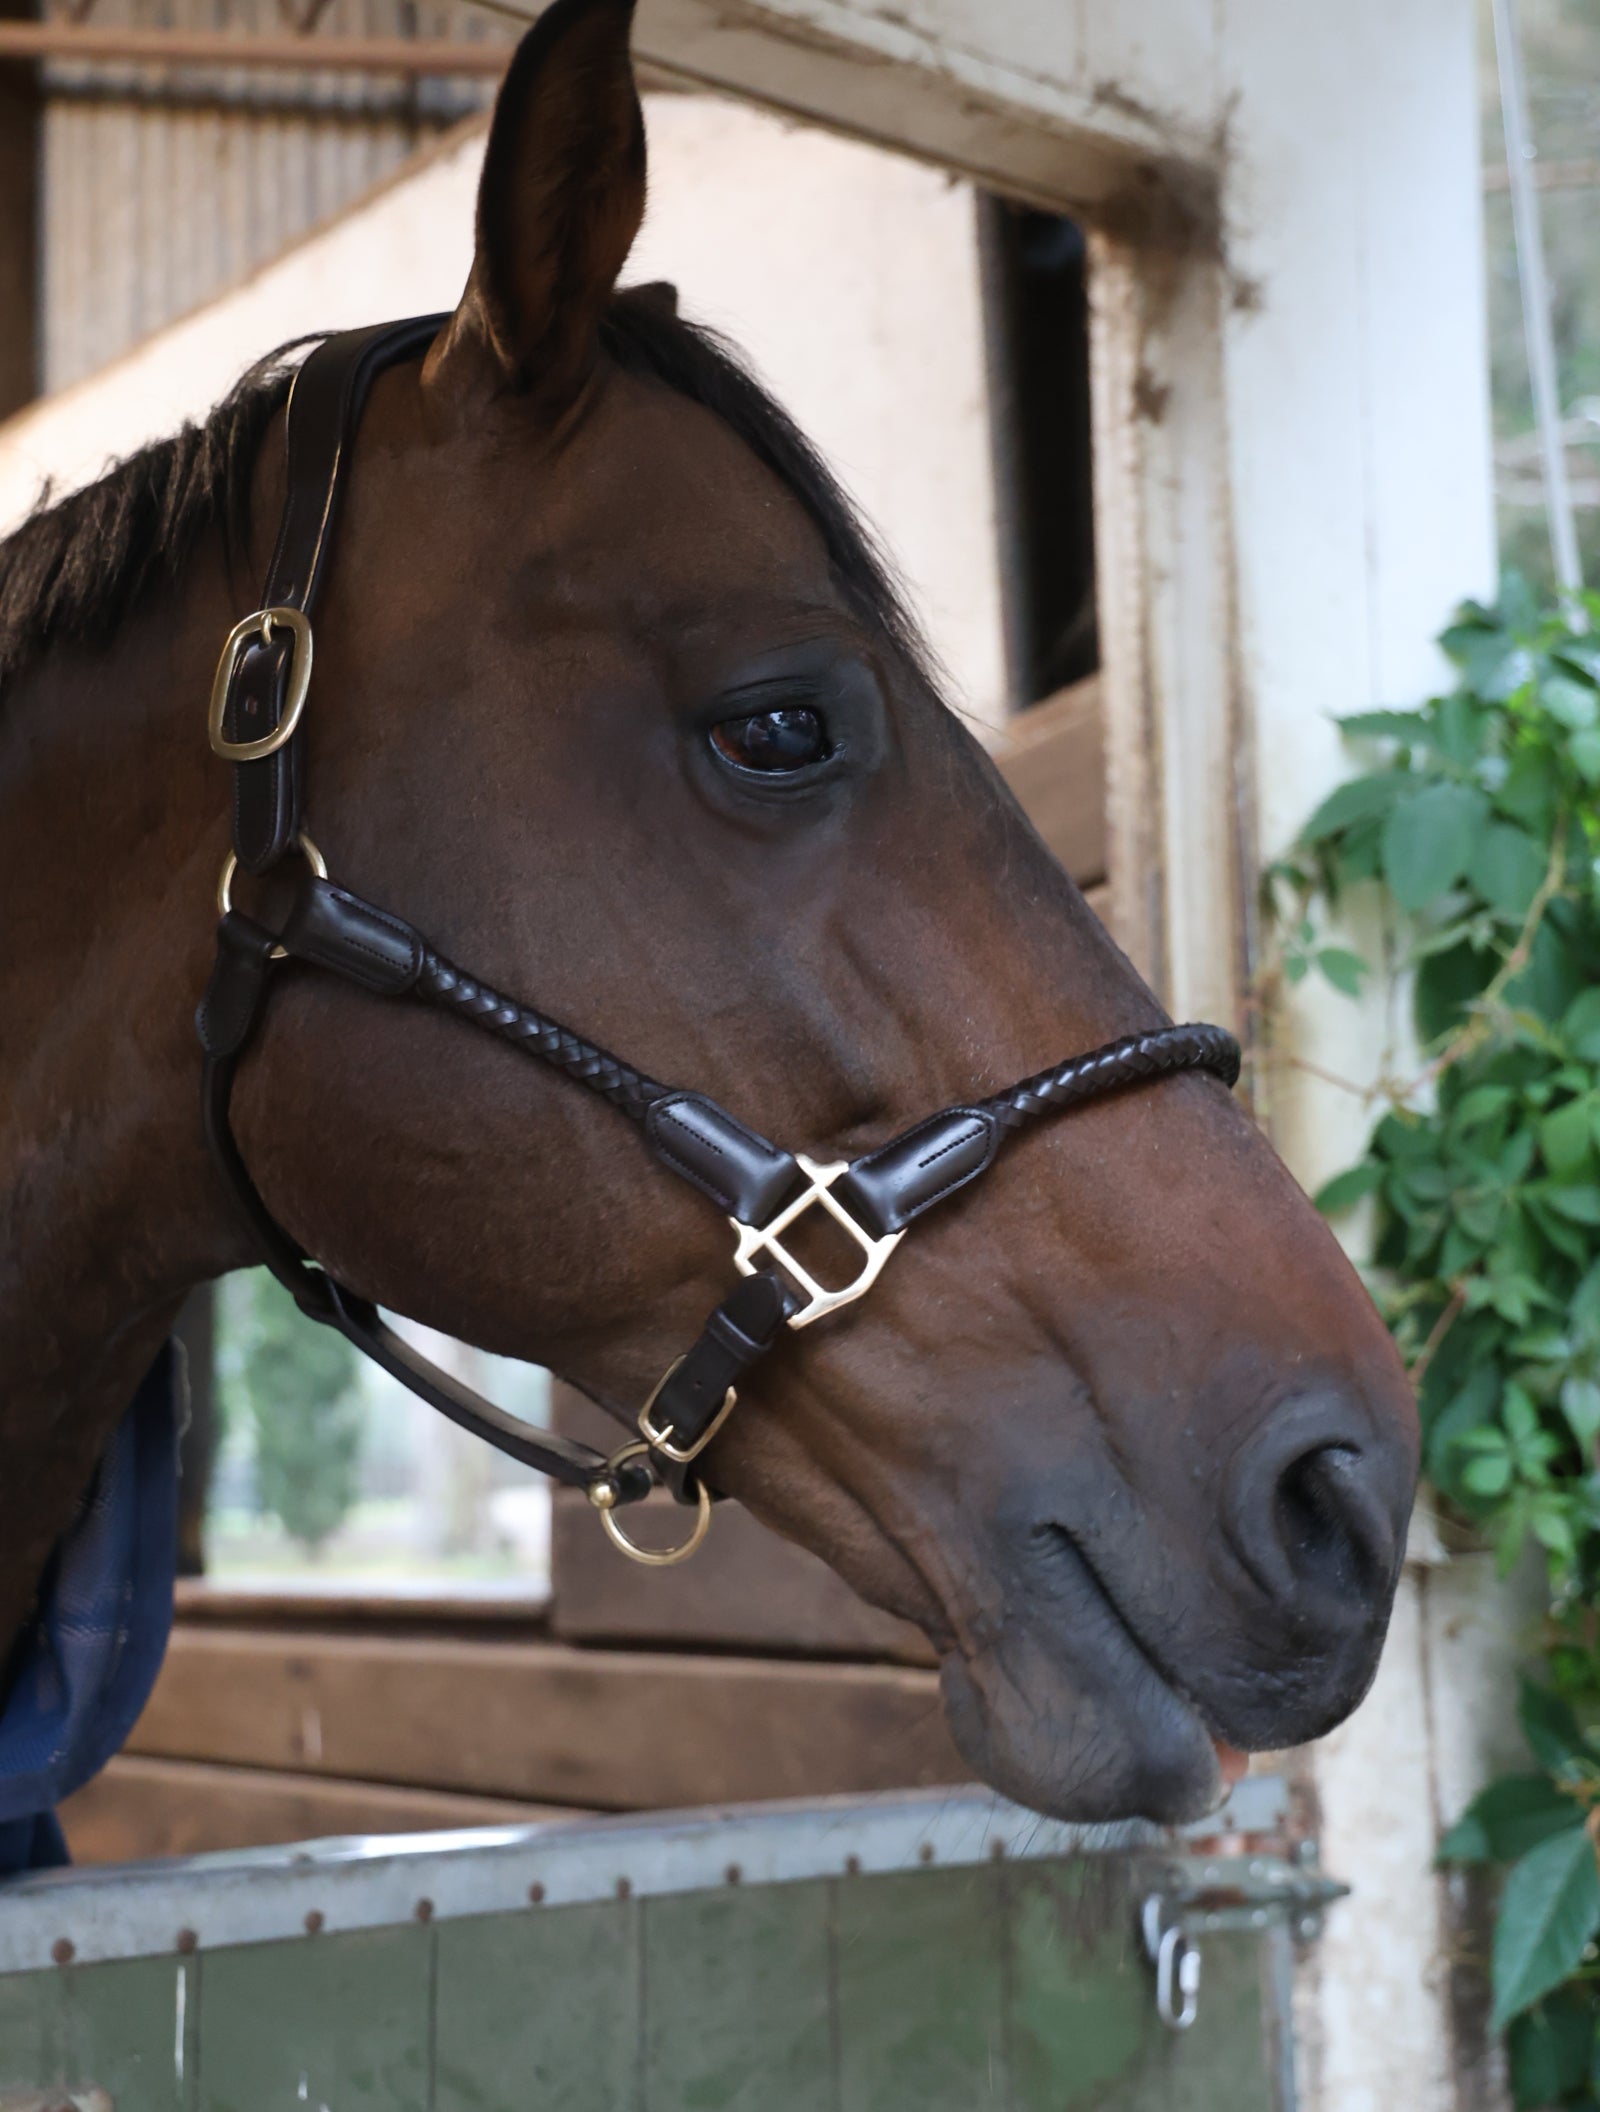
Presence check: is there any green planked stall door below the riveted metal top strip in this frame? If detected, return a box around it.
[0,1856,1285,2112]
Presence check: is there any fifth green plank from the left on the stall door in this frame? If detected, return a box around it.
[834,1869,1007,2112]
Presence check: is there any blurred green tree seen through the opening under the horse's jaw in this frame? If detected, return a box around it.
[222,1269,363,1554]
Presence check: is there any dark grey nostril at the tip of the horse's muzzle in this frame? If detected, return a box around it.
[1226,1398,1404,1614]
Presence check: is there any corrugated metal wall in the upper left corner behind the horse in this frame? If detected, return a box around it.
[40,0,513,391]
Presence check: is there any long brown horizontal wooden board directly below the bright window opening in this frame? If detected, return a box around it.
[129,1628,969,1810]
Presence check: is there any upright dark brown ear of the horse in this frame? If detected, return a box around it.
[428,0,644,408]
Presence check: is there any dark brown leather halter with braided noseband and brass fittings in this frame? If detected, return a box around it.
[196,315,1239,1563]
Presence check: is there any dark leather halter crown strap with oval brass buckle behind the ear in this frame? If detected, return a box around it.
[222,315,450,872]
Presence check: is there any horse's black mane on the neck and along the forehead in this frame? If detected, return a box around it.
[0,289,933,686]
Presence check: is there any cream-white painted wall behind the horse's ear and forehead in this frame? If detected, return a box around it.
[0,93,1005,722]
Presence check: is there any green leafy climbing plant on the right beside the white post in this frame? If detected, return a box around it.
[1264,581,1600,2112]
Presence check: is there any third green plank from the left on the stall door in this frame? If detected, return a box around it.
[433,1901,642,2112]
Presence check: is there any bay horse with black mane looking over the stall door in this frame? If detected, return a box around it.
[0,0,1416,1821]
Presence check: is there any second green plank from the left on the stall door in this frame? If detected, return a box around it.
[195,1924,433,2112]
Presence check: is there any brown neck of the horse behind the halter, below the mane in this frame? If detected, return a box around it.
[0,568,232,1664]
